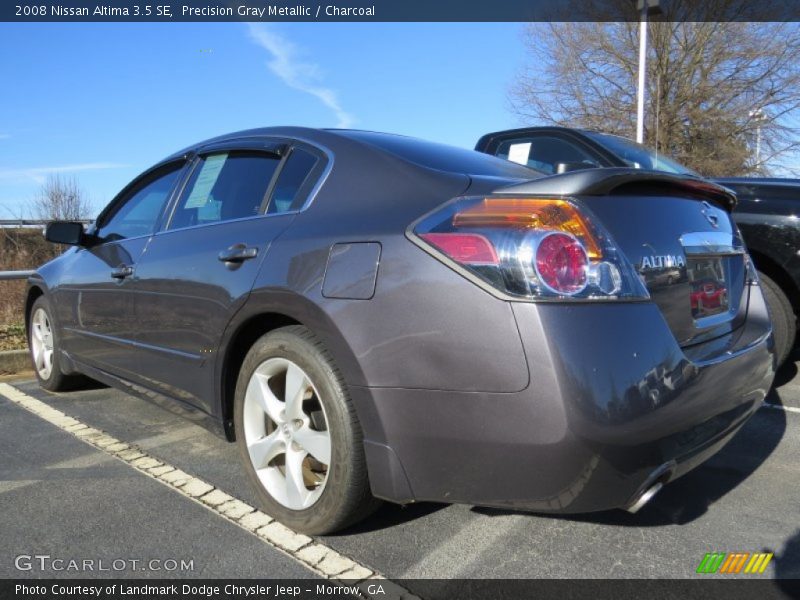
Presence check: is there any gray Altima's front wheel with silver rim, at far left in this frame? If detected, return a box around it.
[28,296,76,392]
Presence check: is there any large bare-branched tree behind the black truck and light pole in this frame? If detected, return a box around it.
[510,8,800,176]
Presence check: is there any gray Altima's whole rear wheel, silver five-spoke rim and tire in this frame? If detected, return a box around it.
[234,326,377,534]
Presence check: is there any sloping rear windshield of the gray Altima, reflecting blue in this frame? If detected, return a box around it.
[337,130,541,179]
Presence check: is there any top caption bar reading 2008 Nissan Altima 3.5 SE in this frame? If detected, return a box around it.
[0,0,800,22]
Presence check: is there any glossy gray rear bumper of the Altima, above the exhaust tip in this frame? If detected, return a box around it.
[352,288,774,513]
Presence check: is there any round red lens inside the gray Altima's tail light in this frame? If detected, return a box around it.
[536,233,589,295]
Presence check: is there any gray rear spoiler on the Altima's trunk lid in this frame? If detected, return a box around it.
[495,167,737,212]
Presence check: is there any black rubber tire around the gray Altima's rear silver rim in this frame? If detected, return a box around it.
[234,325,380,535]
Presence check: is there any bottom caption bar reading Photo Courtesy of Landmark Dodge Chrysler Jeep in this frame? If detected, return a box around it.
[0,575,800,600]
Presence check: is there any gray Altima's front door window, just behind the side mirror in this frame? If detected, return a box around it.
[97,163,183,241]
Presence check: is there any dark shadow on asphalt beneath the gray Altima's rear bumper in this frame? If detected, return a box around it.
[472,358,798,528]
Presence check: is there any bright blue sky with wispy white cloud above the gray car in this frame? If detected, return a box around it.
[0,23,525,218]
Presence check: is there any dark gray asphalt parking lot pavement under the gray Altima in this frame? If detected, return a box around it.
[0,353,800,590]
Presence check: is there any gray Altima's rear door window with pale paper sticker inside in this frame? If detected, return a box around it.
[169,151,280,229]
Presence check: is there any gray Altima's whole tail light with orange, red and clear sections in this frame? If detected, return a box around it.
[409,197,648,300]
